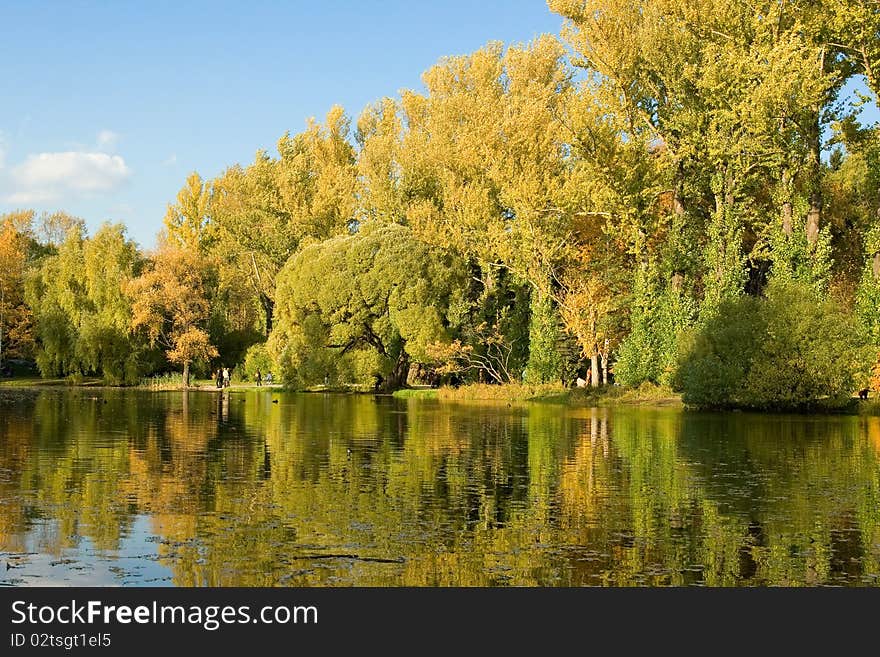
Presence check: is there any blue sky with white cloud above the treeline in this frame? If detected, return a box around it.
[0,0,876,247]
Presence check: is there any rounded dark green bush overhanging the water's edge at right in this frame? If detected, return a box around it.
[677,282,873,410]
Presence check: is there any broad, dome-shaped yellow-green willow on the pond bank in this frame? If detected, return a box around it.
[269,223,465,390]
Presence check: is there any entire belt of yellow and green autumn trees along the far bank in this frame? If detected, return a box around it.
[0,0,880,407]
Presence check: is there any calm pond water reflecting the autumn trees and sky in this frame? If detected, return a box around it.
[0,389,880,586]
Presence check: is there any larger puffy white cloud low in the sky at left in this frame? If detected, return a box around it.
[7,151,131,203]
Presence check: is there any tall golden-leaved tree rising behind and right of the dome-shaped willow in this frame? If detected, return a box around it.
[358,36,600,381]
